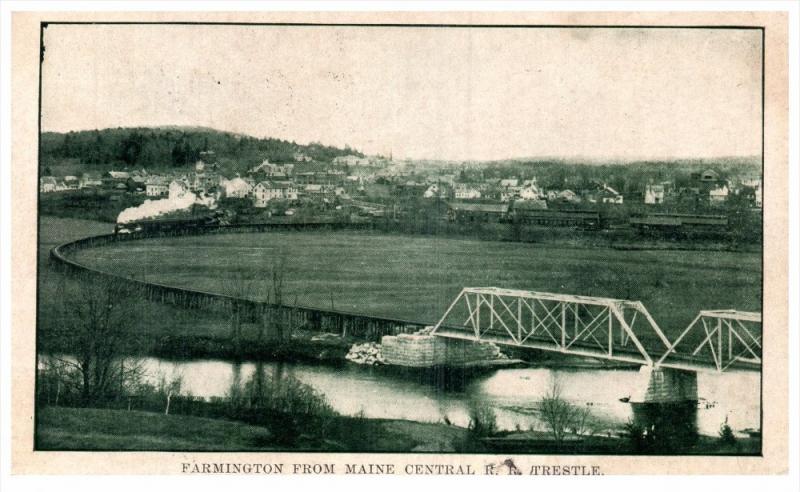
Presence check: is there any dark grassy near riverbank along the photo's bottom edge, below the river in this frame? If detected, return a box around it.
[36,407,761,455]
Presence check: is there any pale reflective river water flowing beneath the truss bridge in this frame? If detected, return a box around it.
[134,358,760,436]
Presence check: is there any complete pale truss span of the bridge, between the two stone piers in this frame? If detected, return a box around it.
[432,287,672,366]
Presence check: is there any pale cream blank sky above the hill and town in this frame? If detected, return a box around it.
[42,25,761,160]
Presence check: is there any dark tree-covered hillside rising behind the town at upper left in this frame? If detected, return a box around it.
[40,127,363,175]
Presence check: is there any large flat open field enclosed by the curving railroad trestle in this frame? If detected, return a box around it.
[69,231,761,336]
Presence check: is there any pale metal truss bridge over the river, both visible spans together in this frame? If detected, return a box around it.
[432,287,762,372]
